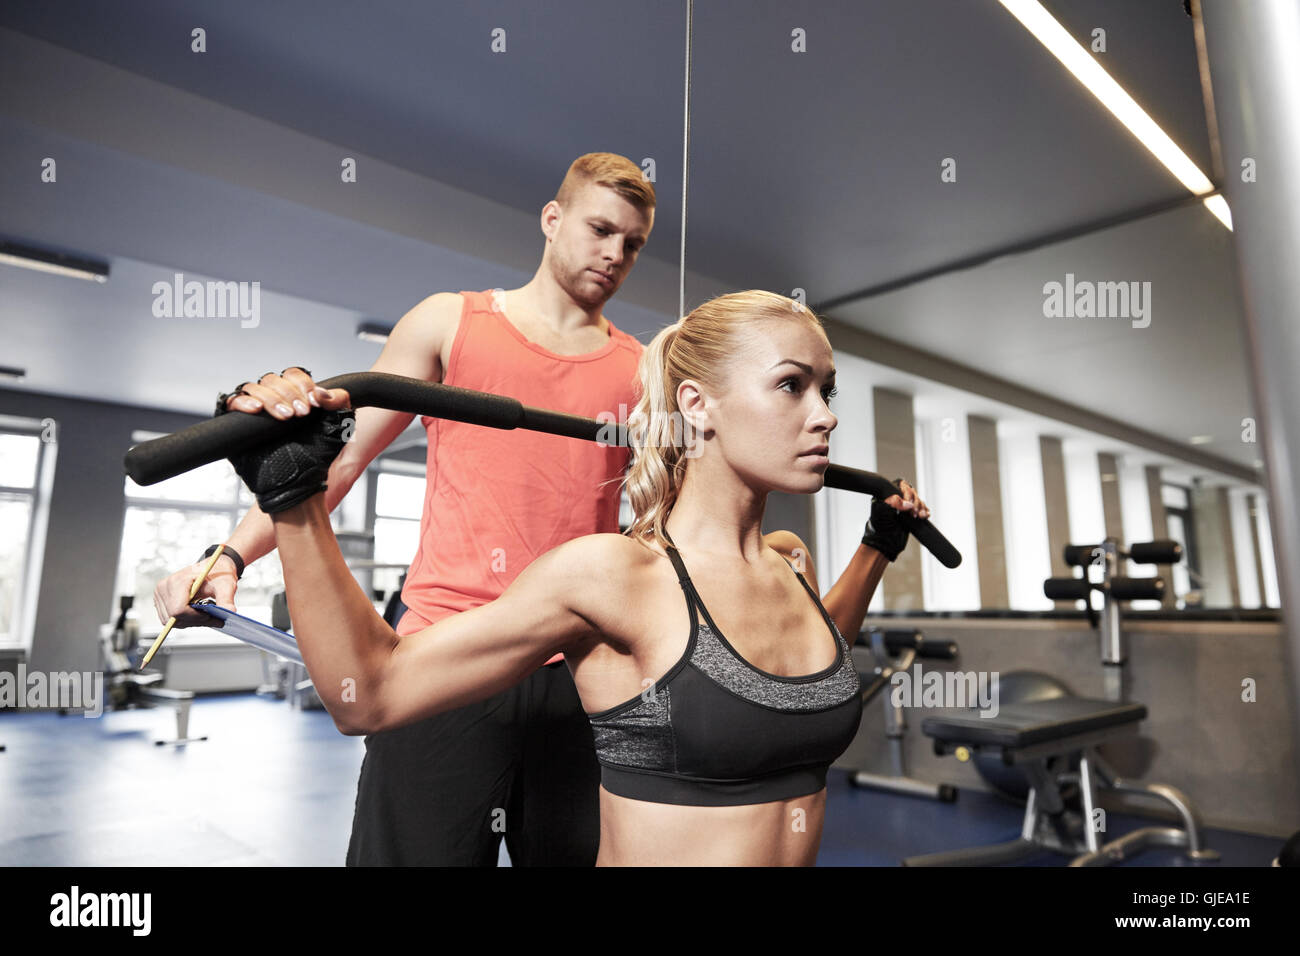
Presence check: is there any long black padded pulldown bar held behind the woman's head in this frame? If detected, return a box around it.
[125,372,962,567]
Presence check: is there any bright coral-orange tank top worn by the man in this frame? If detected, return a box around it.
[398,291,644,663]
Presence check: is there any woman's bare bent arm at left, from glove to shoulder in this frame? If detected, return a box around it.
[272,494,597,735]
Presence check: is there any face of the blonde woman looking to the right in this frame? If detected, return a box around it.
[699,316,839,494]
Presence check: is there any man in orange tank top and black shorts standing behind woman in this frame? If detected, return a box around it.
[155,153,655,866]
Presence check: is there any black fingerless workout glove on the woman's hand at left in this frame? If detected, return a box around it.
[230,408,356,515]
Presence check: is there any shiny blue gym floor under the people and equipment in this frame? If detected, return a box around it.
[0,693,1282,866]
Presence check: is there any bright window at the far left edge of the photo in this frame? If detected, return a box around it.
[0,426,56,648]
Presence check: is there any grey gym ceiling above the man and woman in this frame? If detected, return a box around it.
[0,0,1258,470]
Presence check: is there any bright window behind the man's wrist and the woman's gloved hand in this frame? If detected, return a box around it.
[113,432,285,626]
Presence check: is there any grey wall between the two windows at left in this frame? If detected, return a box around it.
[0,389,199,671]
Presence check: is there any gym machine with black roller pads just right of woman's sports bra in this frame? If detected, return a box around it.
[849,627,957,803]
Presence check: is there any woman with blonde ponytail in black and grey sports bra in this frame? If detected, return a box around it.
[228,290,930,865]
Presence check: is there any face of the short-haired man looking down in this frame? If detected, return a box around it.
[542,185,654,307]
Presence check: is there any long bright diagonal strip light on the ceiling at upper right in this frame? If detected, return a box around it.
[998,0,1232,230]
